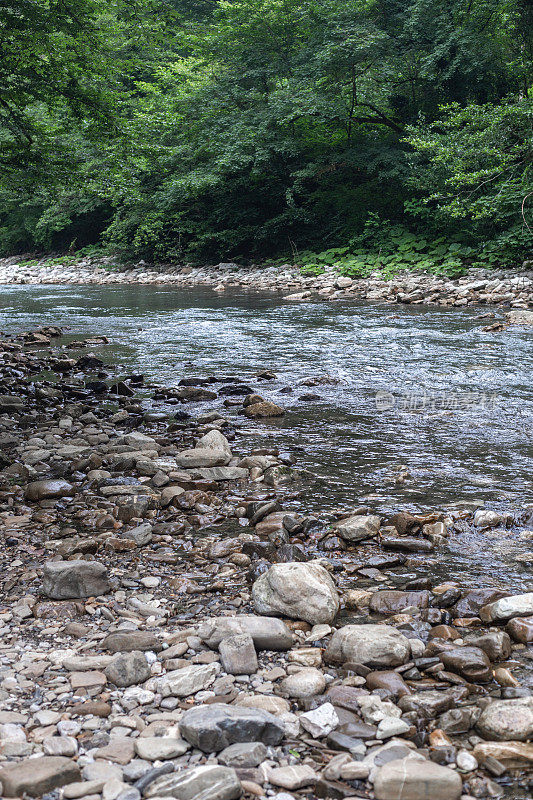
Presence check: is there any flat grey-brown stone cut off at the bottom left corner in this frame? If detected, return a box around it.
[0,756,81,797]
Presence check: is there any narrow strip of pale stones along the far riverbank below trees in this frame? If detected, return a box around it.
[0,258,533,309]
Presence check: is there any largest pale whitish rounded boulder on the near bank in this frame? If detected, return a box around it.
[252,562,339,625]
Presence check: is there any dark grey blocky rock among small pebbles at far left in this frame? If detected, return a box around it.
[43,560,110,600]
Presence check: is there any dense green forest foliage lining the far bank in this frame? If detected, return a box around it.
[0,0,533,268]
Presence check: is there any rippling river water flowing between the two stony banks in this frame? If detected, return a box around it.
[0,286,533,591]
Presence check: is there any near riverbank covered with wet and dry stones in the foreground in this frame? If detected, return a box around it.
[0,328,533,800]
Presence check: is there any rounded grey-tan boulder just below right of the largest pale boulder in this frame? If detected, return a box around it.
[324,625,410,668]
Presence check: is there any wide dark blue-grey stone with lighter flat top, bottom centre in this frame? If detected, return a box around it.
[179,703,285,753]
